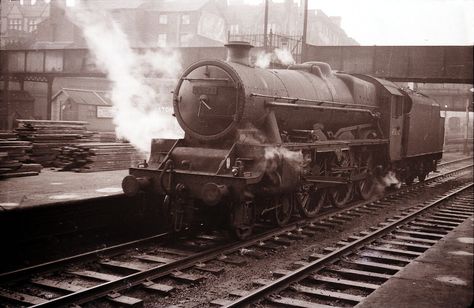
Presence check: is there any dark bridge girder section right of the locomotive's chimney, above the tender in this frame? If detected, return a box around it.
[302,45,473,84]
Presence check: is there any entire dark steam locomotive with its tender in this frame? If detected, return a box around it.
[122,42,444,238]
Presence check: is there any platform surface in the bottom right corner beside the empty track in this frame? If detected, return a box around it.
[356,213,474,308]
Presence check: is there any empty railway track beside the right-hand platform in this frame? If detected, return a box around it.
[214,183,474,307]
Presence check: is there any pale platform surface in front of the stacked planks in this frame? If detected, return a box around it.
[0,168,128,211]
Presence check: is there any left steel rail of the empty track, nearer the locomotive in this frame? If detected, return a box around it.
[223,183,474,307]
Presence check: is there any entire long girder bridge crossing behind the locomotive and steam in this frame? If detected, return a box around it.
[0,45,473,126]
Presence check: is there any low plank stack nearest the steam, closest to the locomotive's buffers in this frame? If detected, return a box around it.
[54,143,146,172]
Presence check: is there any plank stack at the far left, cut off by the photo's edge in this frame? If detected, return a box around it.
[0,133,43,179]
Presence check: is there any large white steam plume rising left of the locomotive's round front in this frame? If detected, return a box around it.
[66,6,183,152]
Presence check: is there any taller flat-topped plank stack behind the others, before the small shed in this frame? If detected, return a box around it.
[16,120,93,167]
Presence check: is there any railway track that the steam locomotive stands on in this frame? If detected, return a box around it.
[0,159,472,306]
